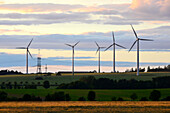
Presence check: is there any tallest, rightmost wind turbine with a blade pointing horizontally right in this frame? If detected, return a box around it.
[129,25,153,76]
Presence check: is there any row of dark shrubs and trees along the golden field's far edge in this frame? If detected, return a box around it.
[0,90,170,101]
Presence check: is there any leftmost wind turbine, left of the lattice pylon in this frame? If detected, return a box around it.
[17,39,33,74]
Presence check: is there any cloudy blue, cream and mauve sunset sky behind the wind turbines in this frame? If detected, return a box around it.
[0,0,170,72]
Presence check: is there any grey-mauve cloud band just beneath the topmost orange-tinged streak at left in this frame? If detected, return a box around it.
[0,11,140,25]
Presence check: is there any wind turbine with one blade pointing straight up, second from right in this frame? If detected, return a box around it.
[105,32,126,73]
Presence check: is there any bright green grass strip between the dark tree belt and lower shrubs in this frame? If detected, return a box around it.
[0,89,170,101]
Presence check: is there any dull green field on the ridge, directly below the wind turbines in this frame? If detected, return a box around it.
[0,72,170,84]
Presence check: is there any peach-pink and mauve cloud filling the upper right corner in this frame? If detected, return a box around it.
[125,0,170,21]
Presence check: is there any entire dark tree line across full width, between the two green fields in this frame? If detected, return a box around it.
[0,76,170,89]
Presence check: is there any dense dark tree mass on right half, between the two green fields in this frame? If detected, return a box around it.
[57,76,170,89]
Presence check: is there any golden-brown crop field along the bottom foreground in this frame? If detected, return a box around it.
[0,101,170,113]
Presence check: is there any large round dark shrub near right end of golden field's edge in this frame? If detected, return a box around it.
[149,90,161,101]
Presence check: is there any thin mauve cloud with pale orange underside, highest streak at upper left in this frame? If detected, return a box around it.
[0,4,106,13]
